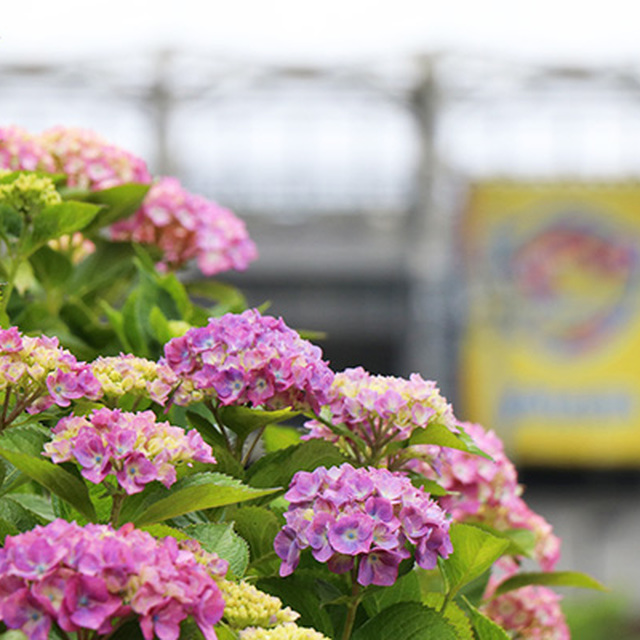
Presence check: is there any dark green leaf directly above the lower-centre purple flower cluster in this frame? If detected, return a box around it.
[247,440,346,487]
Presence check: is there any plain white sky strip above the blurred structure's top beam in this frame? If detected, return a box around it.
[0,0,640,64]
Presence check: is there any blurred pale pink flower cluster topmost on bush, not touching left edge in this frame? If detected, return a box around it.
[38,127,151,191]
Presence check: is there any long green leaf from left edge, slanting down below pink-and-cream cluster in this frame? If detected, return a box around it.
[0,447,96,522]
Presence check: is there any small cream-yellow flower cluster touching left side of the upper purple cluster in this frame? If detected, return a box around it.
[91,353,179,405]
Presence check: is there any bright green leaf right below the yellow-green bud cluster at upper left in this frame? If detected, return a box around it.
[23,201,100,256]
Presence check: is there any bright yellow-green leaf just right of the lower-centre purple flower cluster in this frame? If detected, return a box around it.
[439,524,510,595]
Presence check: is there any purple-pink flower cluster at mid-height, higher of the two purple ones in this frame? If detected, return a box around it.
[164,309,333,411]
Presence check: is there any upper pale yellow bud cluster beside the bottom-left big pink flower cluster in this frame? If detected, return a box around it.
[218,580,300,629]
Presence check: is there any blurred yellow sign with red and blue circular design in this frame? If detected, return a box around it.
[460,183,640,467]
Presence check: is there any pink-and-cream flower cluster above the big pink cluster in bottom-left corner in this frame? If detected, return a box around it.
[44,409,215,494]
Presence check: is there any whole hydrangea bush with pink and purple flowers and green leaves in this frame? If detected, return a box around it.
[0,127,601,640]
